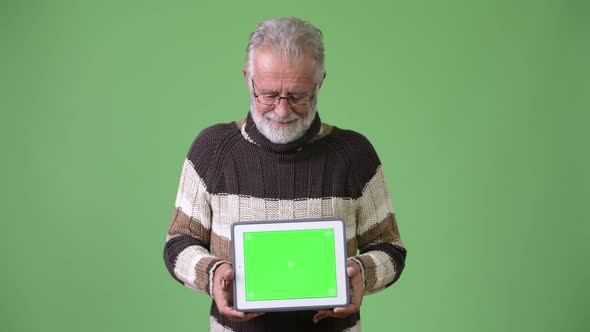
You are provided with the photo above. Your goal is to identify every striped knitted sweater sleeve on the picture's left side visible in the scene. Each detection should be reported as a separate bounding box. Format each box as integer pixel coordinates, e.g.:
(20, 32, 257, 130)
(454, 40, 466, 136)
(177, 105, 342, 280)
(164, 133, 232, 295)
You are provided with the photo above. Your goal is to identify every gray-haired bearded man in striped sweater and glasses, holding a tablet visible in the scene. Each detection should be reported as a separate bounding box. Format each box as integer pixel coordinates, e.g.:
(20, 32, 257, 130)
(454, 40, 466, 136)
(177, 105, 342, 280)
(164, 17, 406, 331)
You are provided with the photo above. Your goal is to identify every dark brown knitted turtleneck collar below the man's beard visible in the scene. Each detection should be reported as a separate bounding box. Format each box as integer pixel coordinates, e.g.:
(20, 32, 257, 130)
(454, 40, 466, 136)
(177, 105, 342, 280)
(244, 112, 322, 153)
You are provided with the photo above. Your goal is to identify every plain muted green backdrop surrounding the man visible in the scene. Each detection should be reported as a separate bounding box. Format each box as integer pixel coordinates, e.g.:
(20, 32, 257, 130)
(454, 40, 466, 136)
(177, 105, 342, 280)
(0, 0, 590, 331)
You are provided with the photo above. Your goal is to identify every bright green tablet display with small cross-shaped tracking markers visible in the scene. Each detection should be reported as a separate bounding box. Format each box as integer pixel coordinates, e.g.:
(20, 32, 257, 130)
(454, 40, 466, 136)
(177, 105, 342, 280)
(244, 229, 336, 301)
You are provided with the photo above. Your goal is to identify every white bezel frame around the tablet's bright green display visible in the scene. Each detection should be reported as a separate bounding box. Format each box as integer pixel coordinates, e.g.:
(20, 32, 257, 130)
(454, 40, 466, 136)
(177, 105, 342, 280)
(231, 218, 349, 312)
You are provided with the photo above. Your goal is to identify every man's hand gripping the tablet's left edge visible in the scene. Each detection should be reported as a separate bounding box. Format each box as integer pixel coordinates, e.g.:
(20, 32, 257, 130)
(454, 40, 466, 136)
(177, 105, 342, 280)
(213, 263, 264, 321)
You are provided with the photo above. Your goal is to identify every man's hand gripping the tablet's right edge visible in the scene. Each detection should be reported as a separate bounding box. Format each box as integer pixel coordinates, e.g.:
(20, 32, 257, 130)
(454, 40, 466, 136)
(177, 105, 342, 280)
(313, 261, 365, 323)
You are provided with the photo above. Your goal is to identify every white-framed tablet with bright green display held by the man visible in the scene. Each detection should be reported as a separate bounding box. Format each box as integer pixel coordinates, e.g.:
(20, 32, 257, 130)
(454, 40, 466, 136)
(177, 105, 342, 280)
(231, 219, 349, 312)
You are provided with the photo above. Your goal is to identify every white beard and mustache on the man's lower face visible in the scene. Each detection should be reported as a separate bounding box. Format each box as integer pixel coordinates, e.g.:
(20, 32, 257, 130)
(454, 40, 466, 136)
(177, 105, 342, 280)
(250, 98, 317, 144)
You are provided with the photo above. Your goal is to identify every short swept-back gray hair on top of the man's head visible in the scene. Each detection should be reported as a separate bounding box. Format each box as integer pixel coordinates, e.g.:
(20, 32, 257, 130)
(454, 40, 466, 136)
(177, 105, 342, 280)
(246, 16, 325, 81)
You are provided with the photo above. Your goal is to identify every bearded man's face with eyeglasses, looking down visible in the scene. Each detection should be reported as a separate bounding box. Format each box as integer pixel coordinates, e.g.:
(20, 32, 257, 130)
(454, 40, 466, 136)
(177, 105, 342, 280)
(246, 48, 316, 144)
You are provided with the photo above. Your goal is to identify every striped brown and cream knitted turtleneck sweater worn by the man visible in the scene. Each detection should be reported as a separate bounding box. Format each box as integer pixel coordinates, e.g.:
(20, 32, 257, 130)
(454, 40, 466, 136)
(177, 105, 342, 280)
(164, 114, 406, 332)
